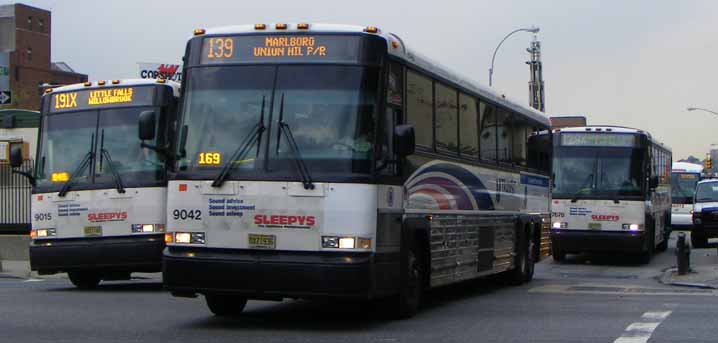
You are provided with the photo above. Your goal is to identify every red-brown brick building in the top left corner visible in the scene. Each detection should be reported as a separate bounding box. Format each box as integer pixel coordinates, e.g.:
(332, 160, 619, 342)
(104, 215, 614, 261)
(0, 4, 87, 110)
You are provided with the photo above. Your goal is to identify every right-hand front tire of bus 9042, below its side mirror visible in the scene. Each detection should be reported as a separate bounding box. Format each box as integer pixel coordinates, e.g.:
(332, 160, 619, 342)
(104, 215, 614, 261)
(397, 244, 426, 319)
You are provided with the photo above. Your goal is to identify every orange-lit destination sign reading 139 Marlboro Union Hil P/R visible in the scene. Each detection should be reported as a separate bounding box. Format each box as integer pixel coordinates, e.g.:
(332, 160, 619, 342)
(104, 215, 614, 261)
(200, 35, 360, 64)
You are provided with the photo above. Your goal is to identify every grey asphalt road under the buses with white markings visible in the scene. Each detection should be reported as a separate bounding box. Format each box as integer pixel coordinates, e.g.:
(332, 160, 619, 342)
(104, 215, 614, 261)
(0, 232, 718, 343)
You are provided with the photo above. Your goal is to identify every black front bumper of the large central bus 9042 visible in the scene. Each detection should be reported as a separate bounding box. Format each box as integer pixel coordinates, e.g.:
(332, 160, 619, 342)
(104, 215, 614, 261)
(162, 247, 374, 300)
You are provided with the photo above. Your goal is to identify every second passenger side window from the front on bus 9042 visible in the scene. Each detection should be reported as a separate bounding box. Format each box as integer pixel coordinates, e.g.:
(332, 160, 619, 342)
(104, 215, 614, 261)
(435, 83, 459, 154)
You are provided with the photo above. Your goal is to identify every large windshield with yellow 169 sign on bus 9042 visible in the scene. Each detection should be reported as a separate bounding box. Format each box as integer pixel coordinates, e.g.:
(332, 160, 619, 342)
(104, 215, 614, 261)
(178, 65, 378, 180)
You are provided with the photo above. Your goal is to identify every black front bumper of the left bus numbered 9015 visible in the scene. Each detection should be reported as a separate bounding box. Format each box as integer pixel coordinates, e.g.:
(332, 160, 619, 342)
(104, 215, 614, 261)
(30, 234, 165, 274)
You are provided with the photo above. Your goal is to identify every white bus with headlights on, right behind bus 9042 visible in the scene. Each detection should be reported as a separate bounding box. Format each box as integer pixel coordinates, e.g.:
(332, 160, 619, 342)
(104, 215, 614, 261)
(551, 126, 671, 262)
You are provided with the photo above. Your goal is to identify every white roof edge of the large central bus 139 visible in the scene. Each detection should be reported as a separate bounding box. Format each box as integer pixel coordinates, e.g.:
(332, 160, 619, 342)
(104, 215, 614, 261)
(200, 23, 551, 126)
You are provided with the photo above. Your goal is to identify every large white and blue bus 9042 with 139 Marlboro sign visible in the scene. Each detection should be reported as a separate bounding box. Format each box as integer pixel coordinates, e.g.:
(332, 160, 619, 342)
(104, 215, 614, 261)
(163, 24, 552, 316)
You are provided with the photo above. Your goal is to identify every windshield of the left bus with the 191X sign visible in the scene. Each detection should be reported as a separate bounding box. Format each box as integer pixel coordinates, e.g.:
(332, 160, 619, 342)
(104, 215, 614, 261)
(37, 107, 164, 189)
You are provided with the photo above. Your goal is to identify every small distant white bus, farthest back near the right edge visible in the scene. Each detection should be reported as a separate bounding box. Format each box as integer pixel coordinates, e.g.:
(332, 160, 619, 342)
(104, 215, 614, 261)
(671, 162, 703, 230)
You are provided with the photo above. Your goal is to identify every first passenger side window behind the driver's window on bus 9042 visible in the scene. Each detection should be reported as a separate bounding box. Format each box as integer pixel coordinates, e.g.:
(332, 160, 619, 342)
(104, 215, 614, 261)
(406, 70, 434, 148)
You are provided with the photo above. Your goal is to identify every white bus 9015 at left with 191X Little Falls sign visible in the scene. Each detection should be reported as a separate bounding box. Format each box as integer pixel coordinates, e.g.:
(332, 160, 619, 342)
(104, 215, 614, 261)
(11, 80, 179, 288)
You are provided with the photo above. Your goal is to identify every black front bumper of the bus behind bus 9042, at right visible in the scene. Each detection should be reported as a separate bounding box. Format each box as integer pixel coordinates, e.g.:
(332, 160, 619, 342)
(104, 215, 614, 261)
(551, 230, 647, 253)
